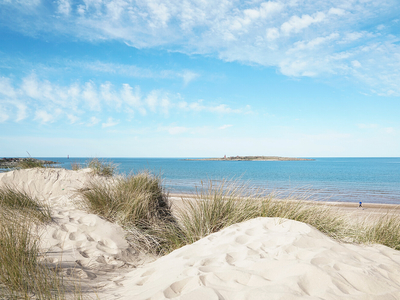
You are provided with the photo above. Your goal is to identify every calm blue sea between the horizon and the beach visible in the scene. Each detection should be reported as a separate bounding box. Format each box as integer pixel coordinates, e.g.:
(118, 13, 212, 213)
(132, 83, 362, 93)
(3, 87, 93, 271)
(6, 157, 400, 204)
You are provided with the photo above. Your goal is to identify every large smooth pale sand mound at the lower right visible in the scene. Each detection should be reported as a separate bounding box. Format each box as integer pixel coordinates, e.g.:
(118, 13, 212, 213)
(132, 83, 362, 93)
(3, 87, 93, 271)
(118, 218, 400, 300)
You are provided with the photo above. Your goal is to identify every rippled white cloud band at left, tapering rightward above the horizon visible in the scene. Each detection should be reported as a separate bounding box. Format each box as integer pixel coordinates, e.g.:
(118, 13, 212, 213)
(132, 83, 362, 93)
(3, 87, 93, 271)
(0, 73, 249, 128)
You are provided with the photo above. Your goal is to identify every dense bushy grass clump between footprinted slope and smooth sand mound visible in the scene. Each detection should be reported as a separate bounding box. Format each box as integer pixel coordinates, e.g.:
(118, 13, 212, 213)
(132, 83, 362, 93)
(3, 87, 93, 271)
(79, 171, 176, 254)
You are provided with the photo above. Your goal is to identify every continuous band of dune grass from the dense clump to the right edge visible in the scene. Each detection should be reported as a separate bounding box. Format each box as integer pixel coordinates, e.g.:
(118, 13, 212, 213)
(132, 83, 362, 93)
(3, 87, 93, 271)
(78, 171, 400, 255)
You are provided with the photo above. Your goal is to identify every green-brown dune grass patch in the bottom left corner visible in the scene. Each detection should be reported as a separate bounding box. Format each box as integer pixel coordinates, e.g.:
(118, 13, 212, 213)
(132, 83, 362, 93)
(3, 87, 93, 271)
(0, 187, 80, 300)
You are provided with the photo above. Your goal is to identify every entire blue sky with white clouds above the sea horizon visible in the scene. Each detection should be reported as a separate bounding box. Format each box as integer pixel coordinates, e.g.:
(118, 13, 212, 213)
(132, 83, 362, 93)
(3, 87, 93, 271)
(0, 0, 400, 157)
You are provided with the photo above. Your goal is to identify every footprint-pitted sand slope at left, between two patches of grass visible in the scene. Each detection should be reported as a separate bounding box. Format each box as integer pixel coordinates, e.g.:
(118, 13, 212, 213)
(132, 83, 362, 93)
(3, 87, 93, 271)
(0, 168, 154, 299)
